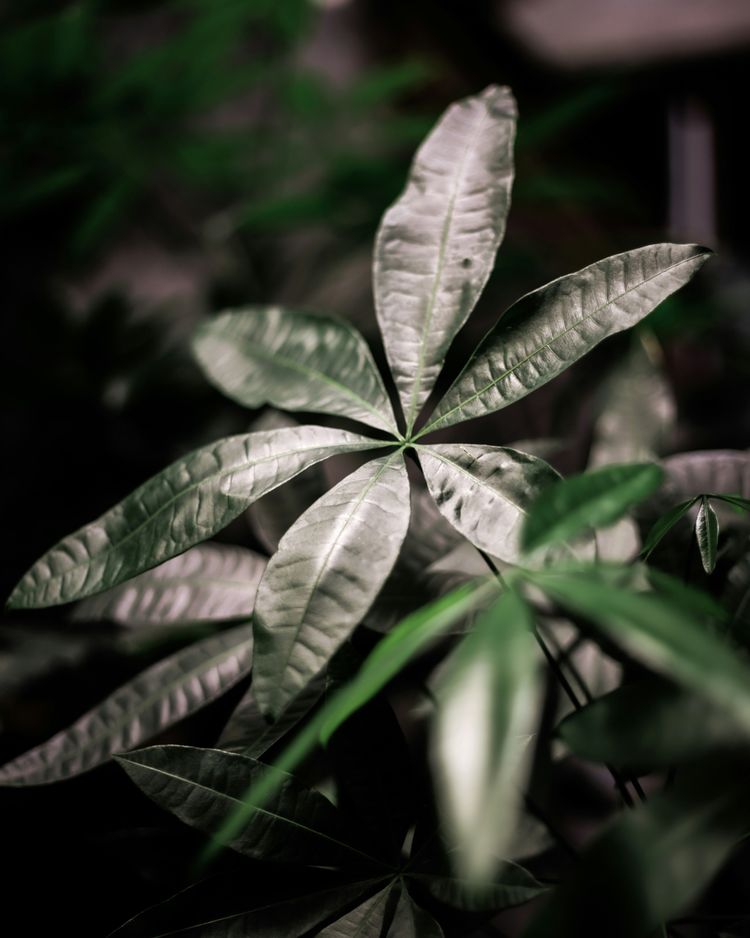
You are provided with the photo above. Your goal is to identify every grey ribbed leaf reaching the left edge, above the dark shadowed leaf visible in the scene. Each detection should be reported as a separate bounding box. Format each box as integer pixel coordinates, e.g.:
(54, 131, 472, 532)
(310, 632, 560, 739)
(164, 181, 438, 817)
(0, 625, 253, 785)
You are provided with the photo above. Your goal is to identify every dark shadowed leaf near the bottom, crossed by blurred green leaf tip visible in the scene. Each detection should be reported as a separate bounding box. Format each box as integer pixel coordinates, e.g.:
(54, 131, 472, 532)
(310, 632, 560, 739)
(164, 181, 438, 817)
(117, 746, 388, 866)
